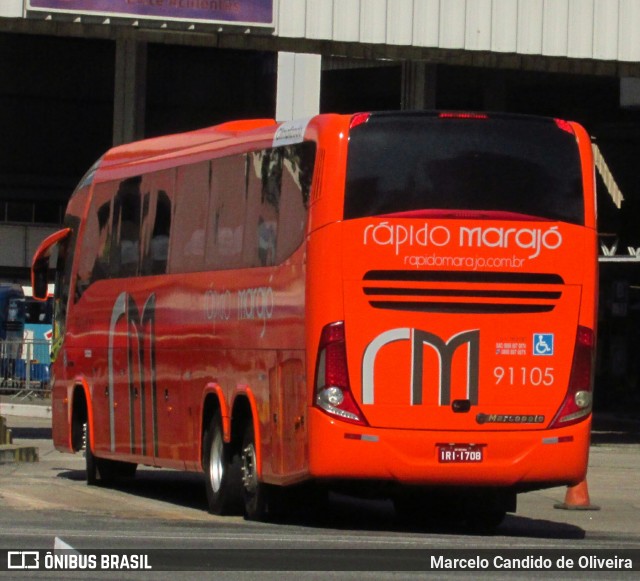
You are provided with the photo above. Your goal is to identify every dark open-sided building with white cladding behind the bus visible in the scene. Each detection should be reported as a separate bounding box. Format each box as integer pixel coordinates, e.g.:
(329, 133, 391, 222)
(0, 0, 640, 401)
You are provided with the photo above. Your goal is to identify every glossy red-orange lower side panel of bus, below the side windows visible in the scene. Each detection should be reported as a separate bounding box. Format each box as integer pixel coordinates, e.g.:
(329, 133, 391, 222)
(64, 253, 305, 474)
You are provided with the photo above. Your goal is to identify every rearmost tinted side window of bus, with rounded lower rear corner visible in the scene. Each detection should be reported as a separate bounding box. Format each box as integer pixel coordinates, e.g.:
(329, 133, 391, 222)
(205, 142, 316, 270)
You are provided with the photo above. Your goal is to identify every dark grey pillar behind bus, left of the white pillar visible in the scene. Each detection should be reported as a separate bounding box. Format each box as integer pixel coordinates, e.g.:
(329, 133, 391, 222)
(113, 38, 147, 145)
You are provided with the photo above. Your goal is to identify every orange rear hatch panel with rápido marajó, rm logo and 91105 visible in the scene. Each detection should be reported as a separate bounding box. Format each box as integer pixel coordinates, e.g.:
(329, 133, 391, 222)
(341, 220, 593, 431)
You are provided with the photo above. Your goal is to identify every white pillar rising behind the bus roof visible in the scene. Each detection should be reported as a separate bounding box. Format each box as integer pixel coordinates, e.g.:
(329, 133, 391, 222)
(276, 52, 322, 121)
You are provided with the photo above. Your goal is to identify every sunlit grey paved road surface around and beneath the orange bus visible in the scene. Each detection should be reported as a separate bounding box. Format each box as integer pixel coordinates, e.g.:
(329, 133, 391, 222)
(0, 416, 640, 579)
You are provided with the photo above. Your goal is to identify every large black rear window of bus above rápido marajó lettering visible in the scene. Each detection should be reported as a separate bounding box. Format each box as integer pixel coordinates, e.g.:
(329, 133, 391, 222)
(344, 114, 584, 224)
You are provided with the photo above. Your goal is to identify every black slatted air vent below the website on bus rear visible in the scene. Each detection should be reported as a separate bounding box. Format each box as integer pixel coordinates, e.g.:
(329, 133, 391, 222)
(363, 270, 564, 314)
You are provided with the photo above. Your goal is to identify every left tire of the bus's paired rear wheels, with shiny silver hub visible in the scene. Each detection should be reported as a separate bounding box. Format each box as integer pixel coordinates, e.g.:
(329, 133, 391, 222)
(202, 411, 242, 515)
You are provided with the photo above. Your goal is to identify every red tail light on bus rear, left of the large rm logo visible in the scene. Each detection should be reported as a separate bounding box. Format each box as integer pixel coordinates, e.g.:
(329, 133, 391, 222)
(315, 321, 367, 426)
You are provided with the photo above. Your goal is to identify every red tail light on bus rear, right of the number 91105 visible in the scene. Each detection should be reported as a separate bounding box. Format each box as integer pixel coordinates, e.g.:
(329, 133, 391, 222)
(549, 327, 595, 428)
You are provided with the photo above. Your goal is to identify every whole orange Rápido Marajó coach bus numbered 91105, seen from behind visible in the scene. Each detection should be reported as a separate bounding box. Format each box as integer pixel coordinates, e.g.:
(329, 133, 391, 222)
(33, 112, 597, 525)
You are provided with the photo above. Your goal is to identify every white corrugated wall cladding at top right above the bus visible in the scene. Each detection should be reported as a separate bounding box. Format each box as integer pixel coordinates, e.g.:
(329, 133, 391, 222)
(275, 0, 640, 62)
